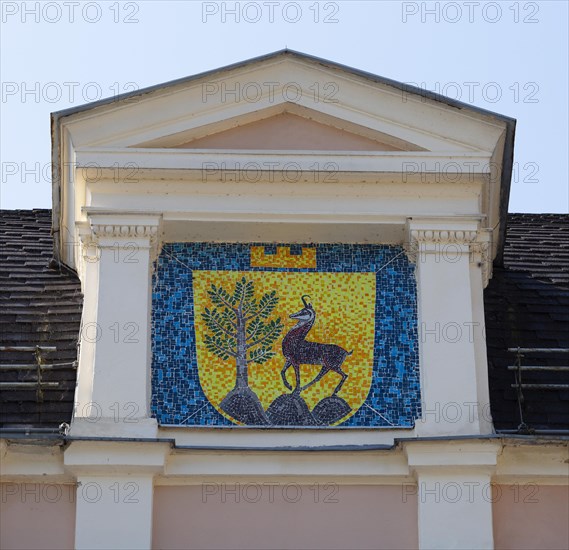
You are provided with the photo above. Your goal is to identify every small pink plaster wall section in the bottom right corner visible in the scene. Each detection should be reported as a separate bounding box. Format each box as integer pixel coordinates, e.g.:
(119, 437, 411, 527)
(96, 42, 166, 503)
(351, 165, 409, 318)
(492, 483, 569, 550)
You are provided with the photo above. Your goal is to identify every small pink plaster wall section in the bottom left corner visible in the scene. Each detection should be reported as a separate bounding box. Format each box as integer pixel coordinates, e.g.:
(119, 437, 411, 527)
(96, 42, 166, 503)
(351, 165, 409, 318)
(0, 483, 76, 550)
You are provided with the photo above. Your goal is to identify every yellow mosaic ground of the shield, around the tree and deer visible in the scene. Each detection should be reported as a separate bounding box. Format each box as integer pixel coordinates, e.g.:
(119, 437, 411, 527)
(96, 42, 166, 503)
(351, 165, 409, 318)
(193, 271, 375, 422)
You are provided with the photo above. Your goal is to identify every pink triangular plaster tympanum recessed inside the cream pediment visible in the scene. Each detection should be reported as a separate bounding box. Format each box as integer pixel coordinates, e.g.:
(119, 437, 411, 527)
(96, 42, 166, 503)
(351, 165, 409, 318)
(178, 113, 400, 151)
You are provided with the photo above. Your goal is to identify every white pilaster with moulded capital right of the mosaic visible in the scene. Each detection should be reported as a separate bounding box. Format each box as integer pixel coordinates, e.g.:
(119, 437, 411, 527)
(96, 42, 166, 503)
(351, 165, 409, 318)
(408, 219, 489, 436)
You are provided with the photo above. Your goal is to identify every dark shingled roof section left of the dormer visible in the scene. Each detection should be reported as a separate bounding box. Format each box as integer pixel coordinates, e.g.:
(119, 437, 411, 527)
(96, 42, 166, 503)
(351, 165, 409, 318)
(0, 210, 83, 428)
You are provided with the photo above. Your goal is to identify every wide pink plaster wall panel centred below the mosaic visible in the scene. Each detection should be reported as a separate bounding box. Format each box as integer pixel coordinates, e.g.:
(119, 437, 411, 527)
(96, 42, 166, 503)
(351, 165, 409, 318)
(153, 482, 418, 550)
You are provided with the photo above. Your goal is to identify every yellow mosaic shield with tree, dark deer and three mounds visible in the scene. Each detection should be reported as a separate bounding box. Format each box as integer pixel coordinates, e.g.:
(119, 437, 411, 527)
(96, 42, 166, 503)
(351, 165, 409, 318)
(194, 271, 375, 426)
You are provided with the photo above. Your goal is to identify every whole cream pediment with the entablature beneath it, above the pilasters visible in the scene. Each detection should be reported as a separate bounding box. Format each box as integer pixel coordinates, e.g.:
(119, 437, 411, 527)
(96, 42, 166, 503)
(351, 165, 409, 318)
(53, 51, 514, 276)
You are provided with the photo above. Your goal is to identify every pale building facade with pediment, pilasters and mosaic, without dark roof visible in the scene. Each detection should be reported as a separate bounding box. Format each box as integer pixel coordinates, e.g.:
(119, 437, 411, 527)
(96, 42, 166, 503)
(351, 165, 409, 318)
(1, 50, 569, 549)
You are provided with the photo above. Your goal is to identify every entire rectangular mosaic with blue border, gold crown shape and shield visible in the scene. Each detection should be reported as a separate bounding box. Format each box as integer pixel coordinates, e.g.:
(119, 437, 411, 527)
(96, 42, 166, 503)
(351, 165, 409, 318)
(151, 243, 421, 428)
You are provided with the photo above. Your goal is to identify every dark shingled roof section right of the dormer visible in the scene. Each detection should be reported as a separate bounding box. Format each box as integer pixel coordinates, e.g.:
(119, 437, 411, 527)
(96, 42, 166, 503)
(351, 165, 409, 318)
(484, 214, 569, 431)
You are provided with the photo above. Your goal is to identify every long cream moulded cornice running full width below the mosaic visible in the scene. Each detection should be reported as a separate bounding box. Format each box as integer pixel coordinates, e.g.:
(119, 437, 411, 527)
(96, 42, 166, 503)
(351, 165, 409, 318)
(0, 436, 569, 485)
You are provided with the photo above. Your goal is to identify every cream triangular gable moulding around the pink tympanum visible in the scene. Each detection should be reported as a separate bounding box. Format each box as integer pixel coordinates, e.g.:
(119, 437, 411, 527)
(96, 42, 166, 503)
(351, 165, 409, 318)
(58, 51, 503, 152)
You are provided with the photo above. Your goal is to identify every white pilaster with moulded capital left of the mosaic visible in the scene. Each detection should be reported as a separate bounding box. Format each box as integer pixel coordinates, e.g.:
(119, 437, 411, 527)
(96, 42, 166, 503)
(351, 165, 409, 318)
(71, 215, 160, 437)
